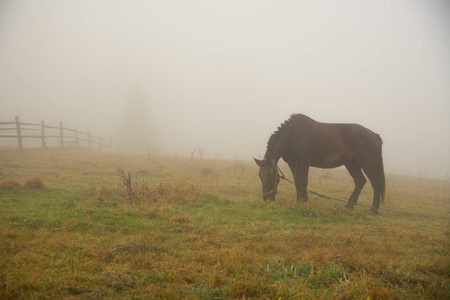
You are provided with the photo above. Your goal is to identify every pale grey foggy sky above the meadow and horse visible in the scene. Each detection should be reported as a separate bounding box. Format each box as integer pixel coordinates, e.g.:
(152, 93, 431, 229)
(0, 0, 450, 179)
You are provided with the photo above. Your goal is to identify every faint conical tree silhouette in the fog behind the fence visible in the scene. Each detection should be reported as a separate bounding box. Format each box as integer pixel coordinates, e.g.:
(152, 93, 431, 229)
(119, 86, 156, 153)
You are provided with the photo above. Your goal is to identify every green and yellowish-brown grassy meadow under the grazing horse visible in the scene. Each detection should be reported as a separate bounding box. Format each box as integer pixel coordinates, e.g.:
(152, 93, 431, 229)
(0, 149, 450, 299)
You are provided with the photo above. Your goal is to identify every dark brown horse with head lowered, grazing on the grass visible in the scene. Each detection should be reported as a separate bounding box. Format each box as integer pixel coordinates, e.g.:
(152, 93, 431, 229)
(255, 114, 386, 214)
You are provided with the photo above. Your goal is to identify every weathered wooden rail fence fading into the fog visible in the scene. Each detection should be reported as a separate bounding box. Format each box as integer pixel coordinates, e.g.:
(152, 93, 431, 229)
(0, 116, 117, 151)
